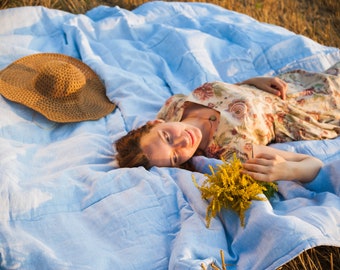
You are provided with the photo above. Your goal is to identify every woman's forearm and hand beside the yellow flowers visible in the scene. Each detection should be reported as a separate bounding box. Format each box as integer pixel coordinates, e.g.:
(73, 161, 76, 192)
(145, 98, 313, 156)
(243, 145, 323, 182)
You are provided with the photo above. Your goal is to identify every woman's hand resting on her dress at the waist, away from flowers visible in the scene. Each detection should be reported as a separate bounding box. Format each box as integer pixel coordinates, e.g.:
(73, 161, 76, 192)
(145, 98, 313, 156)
(237, 77, 287, 99)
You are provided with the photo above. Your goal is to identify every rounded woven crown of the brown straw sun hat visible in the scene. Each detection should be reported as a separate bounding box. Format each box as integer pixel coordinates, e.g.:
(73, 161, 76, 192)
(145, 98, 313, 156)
(35, 60, 86, 98)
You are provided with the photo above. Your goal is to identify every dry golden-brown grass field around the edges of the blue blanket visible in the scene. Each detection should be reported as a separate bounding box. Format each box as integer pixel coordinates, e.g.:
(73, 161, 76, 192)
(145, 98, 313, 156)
(0, 0, 340, 270)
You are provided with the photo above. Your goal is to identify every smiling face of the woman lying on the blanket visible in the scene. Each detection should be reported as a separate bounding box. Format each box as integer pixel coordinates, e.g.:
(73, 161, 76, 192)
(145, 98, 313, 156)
(140, 120, 202, 167)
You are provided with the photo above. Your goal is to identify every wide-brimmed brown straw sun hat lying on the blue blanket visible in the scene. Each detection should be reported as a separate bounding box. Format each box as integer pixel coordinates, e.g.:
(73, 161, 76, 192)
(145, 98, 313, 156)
(0, 53, 116, 123)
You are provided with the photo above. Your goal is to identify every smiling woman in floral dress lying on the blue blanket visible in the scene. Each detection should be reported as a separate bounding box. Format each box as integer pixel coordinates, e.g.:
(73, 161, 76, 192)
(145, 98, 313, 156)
(116, 63, 340, 182)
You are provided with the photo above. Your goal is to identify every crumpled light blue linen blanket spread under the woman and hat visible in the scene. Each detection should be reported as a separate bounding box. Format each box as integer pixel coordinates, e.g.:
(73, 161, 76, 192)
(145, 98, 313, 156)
(0, 2, 340, 270)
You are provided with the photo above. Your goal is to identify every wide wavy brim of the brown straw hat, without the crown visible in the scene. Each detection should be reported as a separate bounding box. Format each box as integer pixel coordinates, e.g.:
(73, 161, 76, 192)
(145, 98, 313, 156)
(0, 53, 116, 123)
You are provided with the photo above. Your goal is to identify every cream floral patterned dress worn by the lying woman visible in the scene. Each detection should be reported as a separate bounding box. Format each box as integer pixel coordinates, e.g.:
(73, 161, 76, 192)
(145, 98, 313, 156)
(158, 63, 340, 160)
